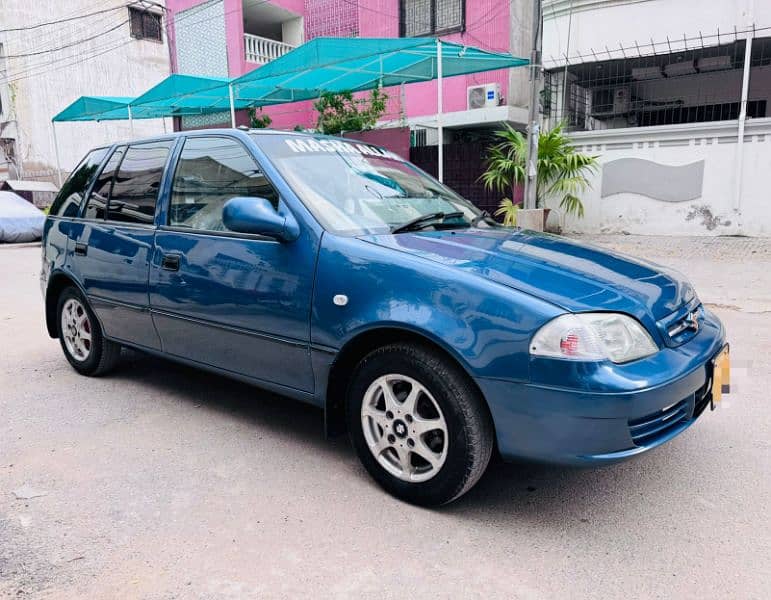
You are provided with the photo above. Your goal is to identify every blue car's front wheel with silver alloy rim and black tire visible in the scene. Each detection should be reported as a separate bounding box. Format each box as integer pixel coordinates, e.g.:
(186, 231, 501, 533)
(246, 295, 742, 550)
(346, 343, 494, 506)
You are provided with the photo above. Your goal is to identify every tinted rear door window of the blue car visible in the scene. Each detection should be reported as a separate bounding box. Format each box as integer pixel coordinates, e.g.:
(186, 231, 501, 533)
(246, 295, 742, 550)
(107, 140, 174, 223)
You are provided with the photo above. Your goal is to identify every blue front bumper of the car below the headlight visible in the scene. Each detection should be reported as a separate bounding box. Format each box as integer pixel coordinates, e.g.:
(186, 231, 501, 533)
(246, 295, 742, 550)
(477, 310, 725, 466)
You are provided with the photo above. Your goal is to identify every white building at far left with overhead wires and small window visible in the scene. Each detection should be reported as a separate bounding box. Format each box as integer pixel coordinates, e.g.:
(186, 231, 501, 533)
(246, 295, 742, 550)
(0, 0, 170, 182)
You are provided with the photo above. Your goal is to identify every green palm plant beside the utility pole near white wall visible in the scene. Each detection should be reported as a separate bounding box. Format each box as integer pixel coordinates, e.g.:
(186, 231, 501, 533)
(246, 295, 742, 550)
(480, 123, 597, 225)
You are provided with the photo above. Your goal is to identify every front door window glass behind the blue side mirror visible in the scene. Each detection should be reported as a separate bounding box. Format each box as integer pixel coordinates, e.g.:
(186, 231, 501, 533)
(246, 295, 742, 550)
(169, 137, 278, 231)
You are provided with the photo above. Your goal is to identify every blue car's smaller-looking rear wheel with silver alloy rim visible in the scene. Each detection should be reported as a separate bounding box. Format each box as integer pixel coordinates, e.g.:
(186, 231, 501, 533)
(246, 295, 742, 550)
(56, 286, 121, 376)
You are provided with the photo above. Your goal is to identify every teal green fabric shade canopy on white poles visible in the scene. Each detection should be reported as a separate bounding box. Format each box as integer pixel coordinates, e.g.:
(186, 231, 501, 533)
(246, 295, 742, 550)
(53, 38, 528, 121)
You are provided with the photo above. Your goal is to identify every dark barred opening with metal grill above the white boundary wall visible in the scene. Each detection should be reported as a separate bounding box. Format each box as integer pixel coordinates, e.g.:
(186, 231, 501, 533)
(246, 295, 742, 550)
(541, 36, 771, 131)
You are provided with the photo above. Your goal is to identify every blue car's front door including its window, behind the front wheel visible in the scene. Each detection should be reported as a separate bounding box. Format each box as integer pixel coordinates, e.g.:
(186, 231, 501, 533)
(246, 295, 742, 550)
(150, 135, 318, 392)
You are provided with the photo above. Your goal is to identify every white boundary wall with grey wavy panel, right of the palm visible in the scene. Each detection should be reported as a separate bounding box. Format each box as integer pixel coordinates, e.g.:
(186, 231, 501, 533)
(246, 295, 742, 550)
(549, 119, 771, 236)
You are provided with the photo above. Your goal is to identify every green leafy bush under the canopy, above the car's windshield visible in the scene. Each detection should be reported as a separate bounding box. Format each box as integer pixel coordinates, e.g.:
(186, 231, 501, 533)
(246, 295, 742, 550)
(313, 89, 388, 135)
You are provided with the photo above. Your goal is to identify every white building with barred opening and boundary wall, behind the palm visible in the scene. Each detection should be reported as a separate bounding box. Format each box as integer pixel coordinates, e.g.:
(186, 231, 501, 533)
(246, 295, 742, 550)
(543, 0, 771, 236)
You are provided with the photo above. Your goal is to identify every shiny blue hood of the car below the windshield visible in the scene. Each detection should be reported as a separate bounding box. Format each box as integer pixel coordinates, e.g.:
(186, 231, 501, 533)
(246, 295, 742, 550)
(361, 228, 695, 320)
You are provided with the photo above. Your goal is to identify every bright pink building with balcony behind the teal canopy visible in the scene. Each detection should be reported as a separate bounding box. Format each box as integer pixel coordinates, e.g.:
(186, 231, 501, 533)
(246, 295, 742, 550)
(166, 0, 530, 135)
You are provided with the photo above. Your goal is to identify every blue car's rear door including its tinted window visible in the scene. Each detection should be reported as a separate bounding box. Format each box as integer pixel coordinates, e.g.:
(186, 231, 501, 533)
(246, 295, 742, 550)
(70, 140, 175, 349)
